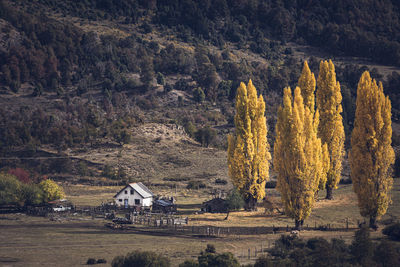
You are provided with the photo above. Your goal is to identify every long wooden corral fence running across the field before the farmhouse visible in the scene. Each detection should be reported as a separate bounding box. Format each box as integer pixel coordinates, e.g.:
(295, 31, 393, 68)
(0, 205, 363, 237)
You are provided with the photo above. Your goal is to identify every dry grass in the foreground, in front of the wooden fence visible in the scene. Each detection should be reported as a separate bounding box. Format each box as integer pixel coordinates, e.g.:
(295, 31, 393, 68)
(0, 215, 353, 266)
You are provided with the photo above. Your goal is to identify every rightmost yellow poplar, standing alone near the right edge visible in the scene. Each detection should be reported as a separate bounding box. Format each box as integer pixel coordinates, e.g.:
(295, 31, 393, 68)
(350, 71, 395, 228)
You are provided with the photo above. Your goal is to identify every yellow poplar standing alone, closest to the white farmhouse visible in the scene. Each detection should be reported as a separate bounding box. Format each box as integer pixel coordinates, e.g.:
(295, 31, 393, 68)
(228, 80, 271, 210)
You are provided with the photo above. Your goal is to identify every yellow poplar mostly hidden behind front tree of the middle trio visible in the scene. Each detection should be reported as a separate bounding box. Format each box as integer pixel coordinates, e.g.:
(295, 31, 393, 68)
(297, 61, 330, 193)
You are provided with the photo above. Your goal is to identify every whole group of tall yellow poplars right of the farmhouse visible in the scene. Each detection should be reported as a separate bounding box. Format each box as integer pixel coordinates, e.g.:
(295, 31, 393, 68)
(228, 61, 394, 228)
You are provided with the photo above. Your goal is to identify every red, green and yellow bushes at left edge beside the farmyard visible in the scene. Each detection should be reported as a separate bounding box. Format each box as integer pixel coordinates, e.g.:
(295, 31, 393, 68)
(0, 168, 65, 206)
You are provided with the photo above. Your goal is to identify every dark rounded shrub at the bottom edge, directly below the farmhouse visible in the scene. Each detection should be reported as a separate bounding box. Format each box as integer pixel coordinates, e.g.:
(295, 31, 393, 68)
(111, 250, 170, 267)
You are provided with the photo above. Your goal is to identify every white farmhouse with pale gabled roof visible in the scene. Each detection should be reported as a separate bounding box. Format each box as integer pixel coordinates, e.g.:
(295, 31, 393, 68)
(114, 182, 154, 208)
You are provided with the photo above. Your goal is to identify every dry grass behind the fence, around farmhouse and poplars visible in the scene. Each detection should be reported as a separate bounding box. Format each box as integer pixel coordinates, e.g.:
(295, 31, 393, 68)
(64, 179, 400, 227)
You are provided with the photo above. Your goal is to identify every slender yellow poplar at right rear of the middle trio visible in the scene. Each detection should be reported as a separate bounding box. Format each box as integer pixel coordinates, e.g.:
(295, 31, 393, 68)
(317, 60, 345, 199)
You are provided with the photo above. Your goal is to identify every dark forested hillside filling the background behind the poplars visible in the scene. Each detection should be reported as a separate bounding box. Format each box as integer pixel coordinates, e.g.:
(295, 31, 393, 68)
(0, 0, 400, 180)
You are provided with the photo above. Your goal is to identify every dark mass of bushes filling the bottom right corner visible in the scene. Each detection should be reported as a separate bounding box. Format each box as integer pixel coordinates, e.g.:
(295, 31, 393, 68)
(266, 227, 400, 266)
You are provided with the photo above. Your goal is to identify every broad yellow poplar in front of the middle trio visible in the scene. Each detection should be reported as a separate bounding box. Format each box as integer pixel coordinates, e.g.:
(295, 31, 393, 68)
(274, 87, 323, 229)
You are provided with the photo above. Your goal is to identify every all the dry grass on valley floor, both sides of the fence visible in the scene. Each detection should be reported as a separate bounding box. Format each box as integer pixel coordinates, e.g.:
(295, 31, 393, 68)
(0, 179, 400, 266)
